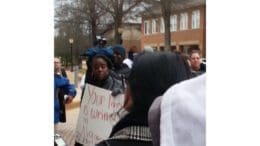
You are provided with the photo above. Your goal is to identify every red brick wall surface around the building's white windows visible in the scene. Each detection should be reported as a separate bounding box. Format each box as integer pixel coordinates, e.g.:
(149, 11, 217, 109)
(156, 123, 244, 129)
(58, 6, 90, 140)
(141, 5, 206, 57)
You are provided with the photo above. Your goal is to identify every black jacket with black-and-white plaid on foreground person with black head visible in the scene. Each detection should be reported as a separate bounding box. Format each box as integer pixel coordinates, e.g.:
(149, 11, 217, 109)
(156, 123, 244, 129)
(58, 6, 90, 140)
(96, 111, 153, 146)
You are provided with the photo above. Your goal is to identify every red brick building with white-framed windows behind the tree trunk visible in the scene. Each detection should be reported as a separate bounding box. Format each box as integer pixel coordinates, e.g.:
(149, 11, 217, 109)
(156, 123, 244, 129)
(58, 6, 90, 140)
(141, 0, 206, 57)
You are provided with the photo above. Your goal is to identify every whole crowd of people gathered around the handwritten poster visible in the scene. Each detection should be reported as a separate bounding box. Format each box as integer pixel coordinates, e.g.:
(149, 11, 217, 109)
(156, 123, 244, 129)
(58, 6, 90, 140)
(54, 37, 206, 146)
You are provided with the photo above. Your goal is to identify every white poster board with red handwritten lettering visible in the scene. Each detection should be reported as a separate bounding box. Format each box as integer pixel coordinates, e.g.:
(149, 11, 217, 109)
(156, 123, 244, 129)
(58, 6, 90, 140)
(76, 84, 124, 146)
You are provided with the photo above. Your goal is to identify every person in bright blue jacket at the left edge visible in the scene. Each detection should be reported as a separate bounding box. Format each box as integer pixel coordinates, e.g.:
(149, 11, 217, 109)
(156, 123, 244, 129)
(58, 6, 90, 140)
(54, 58, 76, 131)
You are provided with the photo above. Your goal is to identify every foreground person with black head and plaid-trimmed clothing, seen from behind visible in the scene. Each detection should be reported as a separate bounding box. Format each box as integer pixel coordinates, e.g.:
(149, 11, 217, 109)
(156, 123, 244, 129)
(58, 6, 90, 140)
(97, 53, 190, 146)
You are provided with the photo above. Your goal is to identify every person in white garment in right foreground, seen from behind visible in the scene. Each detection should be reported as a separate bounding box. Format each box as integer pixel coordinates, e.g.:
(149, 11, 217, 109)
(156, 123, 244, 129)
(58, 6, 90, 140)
(159, 74, 206, 146)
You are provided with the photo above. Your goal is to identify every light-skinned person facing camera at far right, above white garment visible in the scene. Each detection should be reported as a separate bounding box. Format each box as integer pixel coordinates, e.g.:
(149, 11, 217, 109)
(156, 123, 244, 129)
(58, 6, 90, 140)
(190, 50, 205, 77)
